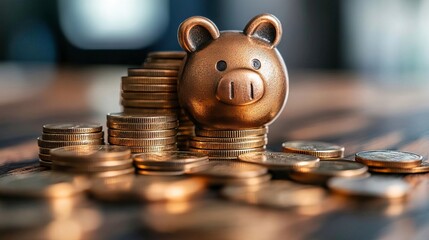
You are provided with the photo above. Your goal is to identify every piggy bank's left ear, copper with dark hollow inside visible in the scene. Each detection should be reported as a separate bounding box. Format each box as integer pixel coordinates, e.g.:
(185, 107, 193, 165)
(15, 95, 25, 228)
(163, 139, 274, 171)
(177, 16, 219, 52)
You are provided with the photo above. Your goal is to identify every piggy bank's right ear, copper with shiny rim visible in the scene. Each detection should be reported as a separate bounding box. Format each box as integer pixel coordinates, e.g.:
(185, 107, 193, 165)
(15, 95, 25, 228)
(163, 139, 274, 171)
(243, 14, 282, 48)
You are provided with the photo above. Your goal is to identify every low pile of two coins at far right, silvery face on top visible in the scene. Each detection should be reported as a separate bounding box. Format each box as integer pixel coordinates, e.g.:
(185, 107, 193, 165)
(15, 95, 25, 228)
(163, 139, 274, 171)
(355, 150, 429, 174)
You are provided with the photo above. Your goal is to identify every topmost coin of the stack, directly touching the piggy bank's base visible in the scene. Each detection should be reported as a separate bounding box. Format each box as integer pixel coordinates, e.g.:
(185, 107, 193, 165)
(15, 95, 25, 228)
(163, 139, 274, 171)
(195, 127, 268, 138)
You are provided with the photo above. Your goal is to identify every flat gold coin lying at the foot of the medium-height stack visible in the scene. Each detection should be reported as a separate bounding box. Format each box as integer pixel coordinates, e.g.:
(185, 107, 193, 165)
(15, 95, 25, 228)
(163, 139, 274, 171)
(133, 151, 208, 166)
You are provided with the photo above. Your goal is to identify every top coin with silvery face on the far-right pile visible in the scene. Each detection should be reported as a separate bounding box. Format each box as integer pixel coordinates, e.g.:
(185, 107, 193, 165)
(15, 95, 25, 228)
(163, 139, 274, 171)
(355, 150, 423, 168)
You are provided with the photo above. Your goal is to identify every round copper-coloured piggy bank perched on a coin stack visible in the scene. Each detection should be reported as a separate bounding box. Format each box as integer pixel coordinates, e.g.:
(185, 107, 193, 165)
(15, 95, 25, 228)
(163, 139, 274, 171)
(177, 14, 288, 130)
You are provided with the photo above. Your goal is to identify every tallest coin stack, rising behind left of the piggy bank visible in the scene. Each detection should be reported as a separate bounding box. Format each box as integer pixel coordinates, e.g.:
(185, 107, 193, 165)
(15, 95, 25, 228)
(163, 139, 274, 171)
(121, 51, 194, 150)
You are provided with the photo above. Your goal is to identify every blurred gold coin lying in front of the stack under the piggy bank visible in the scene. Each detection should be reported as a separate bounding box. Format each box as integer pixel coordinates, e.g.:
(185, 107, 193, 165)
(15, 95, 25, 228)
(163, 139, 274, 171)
(190, 161, 268, 178)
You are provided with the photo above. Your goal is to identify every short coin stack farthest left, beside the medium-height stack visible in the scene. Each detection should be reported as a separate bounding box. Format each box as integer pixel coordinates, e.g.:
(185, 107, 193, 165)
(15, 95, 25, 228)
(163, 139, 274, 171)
(37, 123, 104, 168)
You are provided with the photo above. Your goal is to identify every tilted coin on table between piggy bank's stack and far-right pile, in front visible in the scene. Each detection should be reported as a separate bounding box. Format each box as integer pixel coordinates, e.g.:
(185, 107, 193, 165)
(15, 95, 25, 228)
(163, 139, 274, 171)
(289, 160, 368, 184)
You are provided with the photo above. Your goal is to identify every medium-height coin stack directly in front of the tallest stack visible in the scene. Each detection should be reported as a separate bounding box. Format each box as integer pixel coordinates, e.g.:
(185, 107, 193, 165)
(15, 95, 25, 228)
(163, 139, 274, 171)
(107, 113, 178, 153)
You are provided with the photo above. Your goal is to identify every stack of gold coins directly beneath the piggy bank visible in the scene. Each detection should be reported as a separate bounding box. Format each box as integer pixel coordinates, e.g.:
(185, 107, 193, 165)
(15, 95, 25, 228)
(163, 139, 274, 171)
(189, 127, 268, 160)
